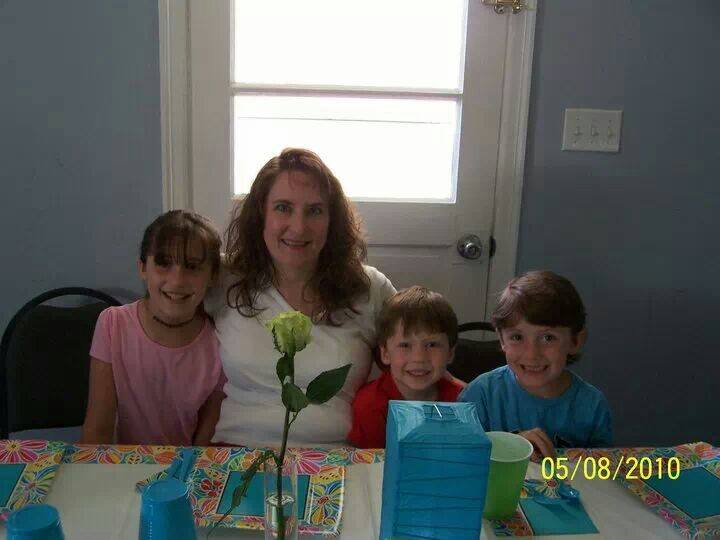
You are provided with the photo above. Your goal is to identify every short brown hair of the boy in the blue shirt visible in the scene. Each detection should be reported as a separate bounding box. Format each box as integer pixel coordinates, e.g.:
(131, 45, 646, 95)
(491, 270, 587, 363)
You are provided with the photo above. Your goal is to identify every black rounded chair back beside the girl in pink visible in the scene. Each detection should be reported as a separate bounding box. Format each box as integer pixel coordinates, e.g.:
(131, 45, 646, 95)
(0, 287, 120, 439)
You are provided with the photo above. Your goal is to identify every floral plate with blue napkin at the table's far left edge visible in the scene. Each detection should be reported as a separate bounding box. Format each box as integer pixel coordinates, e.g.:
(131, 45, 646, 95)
(0, 440, 65, 521)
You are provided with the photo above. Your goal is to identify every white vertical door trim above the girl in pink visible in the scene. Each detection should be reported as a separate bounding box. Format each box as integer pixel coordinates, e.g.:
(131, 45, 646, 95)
(158, 0, 192, 211)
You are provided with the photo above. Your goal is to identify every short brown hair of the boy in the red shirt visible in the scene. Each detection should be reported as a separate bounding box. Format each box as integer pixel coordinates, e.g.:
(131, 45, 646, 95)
(375, 285, 457, 348)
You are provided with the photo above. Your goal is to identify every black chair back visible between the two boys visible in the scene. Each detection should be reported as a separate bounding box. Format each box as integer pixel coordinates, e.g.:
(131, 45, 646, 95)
(448, 322, 505, 383)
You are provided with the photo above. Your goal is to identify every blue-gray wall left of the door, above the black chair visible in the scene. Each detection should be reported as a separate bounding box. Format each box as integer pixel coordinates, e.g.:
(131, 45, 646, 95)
(0, 0, 162, 329)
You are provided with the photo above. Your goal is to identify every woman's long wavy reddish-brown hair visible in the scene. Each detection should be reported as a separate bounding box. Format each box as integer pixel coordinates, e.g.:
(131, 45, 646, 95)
(226, 148, 370, 324)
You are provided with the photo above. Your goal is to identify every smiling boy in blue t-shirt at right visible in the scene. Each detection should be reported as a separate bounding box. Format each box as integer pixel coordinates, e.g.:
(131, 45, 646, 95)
(458, 271, 612, 460)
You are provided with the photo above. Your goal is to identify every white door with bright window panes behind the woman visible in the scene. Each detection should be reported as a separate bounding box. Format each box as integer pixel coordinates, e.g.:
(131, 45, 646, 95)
(171, 0, 534, 322)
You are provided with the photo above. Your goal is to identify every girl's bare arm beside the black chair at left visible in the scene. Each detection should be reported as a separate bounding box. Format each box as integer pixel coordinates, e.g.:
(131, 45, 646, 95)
(80, 357, 117, 444)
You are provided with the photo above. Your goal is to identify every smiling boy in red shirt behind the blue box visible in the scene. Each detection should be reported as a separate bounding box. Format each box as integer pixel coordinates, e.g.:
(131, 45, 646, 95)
(348, 286, 463, 448)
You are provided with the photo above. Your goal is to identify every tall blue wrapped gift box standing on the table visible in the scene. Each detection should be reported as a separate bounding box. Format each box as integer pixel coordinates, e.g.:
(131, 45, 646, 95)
(380, 401, 491, 540)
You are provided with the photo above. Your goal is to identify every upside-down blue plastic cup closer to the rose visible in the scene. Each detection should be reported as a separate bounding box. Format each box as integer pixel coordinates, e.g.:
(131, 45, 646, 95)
(139, 478, 197, 540)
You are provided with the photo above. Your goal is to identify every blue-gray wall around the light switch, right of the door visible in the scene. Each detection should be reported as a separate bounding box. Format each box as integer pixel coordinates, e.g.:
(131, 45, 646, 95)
(518, 0, 720, 445)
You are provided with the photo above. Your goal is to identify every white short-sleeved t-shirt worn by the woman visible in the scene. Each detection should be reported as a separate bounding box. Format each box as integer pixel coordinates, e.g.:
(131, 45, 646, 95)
(209, 266, 395, 447)
